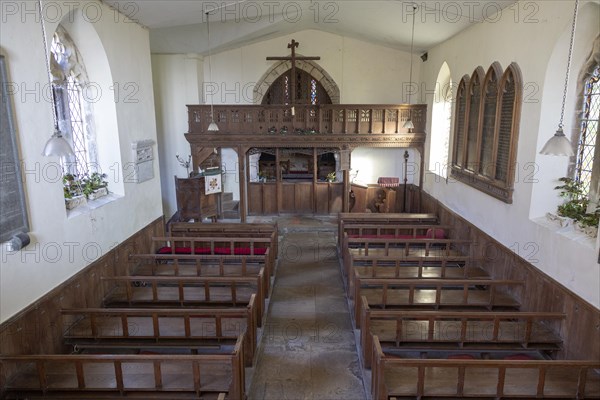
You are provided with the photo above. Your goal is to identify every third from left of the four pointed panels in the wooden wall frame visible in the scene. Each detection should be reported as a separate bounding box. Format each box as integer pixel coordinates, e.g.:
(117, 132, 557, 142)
(479, 63, 502, 178)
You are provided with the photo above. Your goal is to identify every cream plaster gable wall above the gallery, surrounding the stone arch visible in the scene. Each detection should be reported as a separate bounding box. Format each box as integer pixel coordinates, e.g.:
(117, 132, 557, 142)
(205, 30, 421, 104)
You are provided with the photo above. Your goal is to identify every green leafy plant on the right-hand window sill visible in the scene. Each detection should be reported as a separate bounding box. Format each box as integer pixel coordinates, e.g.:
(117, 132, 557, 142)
(554, 178, 600, 227)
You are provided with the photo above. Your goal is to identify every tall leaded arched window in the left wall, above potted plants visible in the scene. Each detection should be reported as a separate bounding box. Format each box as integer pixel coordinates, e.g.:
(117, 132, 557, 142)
(50, 25, 98, 177)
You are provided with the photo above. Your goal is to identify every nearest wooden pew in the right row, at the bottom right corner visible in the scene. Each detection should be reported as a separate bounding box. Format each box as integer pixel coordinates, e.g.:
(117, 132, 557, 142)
(371, 336, 600, 400)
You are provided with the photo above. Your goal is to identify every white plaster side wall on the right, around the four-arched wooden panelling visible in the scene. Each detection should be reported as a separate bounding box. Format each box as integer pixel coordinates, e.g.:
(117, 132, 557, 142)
(421, 0, 600, 307)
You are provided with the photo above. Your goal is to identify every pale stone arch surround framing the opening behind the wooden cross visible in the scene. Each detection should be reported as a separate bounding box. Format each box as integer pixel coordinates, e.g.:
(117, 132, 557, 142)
(253, 54, 340, 104)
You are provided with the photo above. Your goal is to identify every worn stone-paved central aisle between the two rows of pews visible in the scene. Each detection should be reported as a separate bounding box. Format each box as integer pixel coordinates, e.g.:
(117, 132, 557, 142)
(248, 220, 367, 400)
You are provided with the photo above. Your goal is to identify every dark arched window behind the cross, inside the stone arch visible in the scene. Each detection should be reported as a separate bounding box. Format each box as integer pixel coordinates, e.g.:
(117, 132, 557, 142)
(262, 69, 331, 105)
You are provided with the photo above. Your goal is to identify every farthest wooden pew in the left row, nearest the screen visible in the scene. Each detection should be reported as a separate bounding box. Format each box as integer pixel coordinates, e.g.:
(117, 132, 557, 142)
(167, 222, 279, 265)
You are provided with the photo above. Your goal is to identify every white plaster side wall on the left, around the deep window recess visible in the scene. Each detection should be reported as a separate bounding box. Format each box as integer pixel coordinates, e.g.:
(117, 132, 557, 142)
(0, 1, 162, 321)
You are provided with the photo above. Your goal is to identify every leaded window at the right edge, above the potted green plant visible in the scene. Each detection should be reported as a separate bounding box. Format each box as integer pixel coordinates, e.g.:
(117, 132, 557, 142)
(575, 65, 600, 196)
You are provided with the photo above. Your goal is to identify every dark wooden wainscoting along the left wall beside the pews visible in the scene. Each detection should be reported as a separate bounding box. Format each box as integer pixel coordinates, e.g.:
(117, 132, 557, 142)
(0, 217, 164, 355)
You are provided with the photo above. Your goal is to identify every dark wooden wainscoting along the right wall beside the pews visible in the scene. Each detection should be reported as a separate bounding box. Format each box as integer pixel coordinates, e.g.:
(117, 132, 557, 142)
(421, 192, 600, 360)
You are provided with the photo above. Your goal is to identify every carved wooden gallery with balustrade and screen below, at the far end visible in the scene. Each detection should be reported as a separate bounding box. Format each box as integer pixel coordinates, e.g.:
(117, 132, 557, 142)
(185, 104, 427, 222)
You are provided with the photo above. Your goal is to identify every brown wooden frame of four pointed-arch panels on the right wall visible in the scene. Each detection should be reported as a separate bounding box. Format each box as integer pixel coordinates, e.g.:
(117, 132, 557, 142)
(451, 63, 523, 204)
